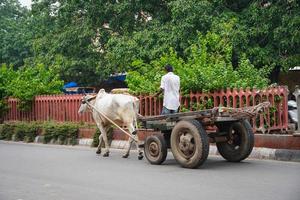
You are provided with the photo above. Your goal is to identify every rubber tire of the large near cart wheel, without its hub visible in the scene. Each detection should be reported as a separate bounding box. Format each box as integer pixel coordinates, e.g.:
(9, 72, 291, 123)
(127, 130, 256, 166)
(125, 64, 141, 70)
(170, 120, 209, 169)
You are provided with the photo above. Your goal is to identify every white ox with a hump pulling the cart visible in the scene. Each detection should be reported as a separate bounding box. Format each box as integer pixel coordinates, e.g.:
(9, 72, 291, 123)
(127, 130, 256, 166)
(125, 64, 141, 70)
(78, 89, 143, 159)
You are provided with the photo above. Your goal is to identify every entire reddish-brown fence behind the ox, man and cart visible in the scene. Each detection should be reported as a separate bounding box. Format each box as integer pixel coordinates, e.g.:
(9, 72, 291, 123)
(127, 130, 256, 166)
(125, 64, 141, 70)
(4, 86, 288, 132)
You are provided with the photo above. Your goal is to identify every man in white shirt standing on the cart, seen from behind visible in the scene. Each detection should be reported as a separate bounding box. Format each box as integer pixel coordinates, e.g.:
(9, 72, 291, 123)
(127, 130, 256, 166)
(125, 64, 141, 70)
(155, 64, 180, 115)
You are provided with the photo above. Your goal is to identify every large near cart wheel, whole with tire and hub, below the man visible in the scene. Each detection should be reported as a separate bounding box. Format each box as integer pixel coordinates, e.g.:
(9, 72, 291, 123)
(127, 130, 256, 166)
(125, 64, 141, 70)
(171, 120, 209, 168)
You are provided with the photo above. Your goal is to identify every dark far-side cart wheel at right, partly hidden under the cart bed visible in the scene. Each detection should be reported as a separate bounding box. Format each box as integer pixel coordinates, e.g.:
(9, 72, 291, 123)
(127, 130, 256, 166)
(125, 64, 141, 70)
(217, 120, 254, 162)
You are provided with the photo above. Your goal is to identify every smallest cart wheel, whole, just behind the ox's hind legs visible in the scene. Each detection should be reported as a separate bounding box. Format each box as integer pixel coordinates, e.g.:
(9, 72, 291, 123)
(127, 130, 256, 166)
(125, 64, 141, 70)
(144, 135, 168, 165)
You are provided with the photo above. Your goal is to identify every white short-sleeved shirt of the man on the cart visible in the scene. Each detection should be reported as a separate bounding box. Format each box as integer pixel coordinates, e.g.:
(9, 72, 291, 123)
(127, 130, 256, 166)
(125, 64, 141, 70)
(160, 72, 180, 110)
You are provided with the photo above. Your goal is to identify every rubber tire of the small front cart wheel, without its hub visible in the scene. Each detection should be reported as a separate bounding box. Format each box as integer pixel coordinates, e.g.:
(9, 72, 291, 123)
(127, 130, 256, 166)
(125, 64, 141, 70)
(144, 135, 168, 165)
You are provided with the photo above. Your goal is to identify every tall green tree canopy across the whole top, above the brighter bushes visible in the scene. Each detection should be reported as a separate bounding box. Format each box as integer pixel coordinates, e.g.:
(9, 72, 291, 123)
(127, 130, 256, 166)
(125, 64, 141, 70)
(0, 0, 300, 85)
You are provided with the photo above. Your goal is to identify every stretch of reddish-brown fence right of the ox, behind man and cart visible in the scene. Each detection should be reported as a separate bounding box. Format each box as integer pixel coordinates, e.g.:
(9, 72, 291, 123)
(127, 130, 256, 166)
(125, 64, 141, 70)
(139, 86, 288, 133)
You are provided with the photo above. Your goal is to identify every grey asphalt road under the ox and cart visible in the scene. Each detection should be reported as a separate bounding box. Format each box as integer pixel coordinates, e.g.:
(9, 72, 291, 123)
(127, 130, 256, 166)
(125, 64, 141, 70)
(0, 141, 300, 200)
